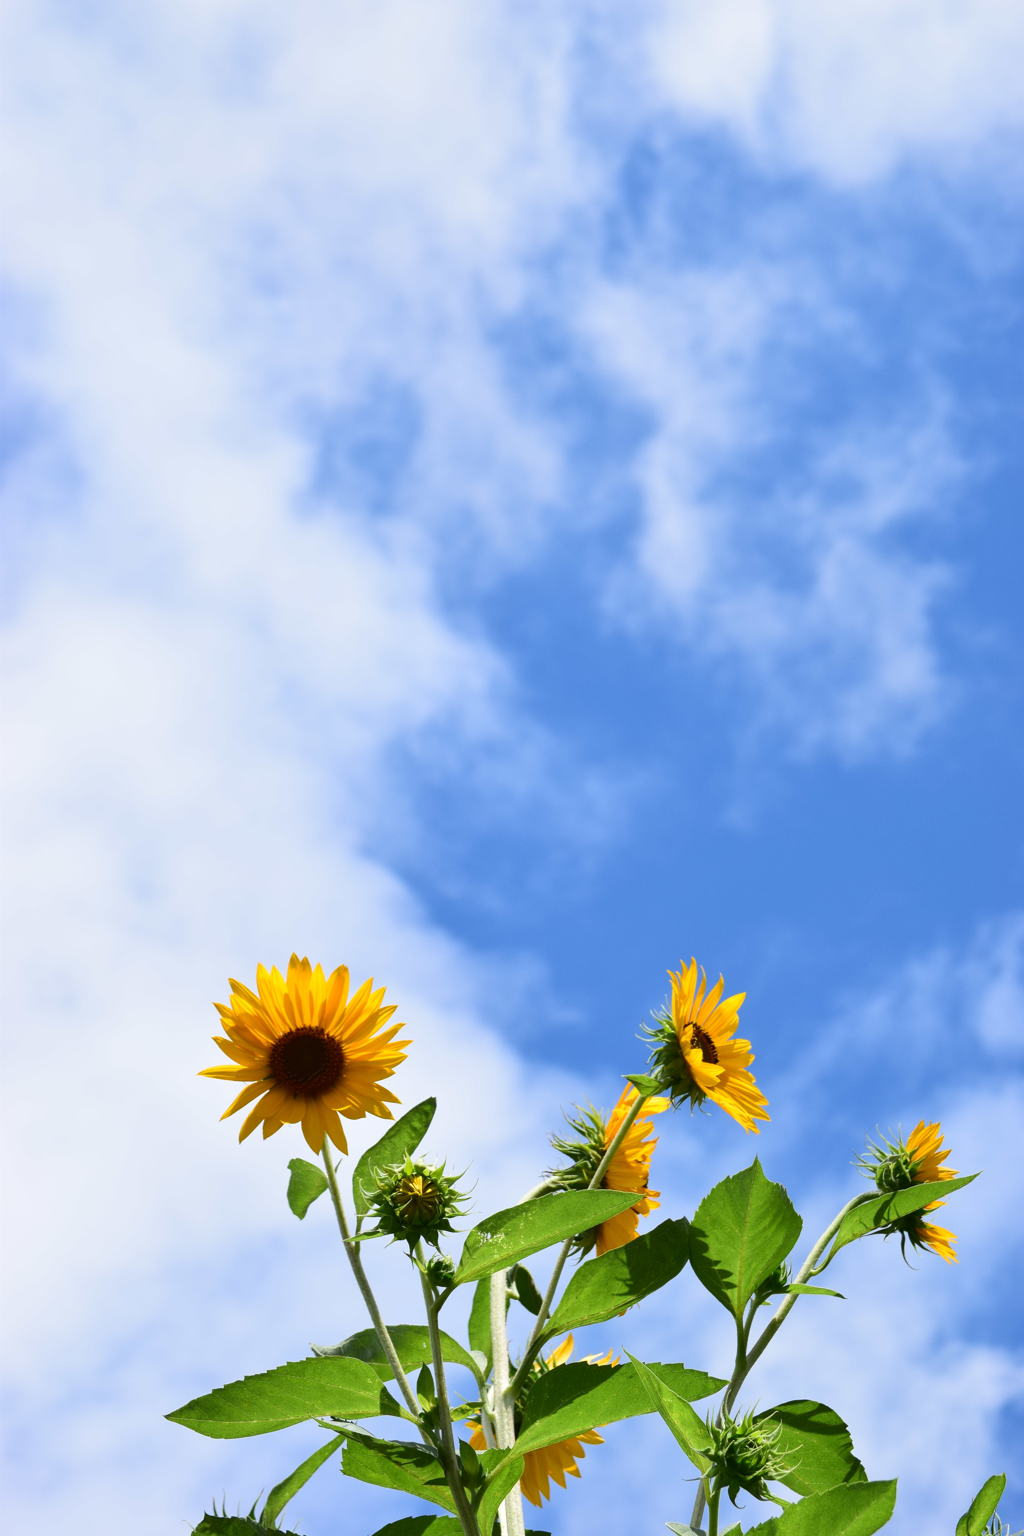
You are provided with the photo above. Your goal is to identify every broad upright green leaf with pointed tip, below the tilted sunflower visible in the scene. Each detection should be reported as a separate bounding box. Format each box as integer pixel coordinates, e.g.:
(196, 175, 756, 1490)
(689, 1158, 803, 1318)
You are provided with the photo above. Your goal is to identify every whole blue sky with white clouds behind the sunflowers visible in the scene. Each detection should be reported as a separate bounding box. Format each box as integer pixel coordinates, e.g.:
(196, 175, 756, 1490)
(0, 0, 1024, 1536)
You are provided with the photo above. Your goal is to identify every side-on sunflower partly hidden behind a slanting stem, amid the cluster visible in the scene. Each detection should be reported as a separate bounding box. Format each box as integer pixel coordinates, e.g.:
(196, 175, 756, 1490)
(551, 1083, 668, 1255)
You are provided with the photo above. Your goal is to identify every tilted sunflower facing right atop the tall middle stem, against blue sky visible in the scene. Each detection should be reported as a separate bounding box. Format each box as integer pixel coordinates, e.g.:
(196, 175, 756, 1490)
(646, 960, 769, 1130)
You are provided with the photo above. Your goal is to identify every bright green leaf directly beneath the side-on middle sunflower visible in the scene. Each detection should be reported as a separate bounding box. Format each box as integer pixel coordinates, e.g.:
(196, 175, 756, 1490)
(454, 1189, 637, 1286)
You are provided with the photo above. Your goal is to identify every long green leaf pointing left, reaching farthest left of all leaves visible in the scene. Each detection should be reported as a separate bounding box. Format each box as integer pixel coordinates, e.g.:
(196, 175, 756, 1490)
(167, 1359, 398, 1439)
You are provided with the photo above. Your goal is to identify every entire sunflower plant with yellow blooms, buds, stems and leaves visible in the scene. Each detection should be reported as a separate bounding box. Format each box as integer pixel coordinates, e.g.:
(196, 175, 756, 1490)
(167, 955, 1006, 1536)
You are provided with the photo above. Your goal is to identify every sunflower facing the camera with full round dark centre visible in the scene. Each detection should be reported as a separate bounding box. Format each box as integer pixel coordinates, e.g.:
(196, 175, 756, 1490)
(200, 955, 408, 1152)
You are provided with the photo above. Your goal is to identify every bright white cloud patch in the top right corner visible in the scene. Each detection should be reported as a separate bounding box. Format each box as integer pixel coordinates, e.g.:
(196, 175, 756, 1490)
(649, 0, 1024, 184)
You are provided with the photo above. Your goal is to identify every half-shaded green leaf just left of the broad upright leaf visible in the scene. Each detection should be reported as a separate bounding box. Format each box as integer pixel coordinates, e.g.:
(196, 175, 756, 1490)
(545, 1221, 689, 1338)
